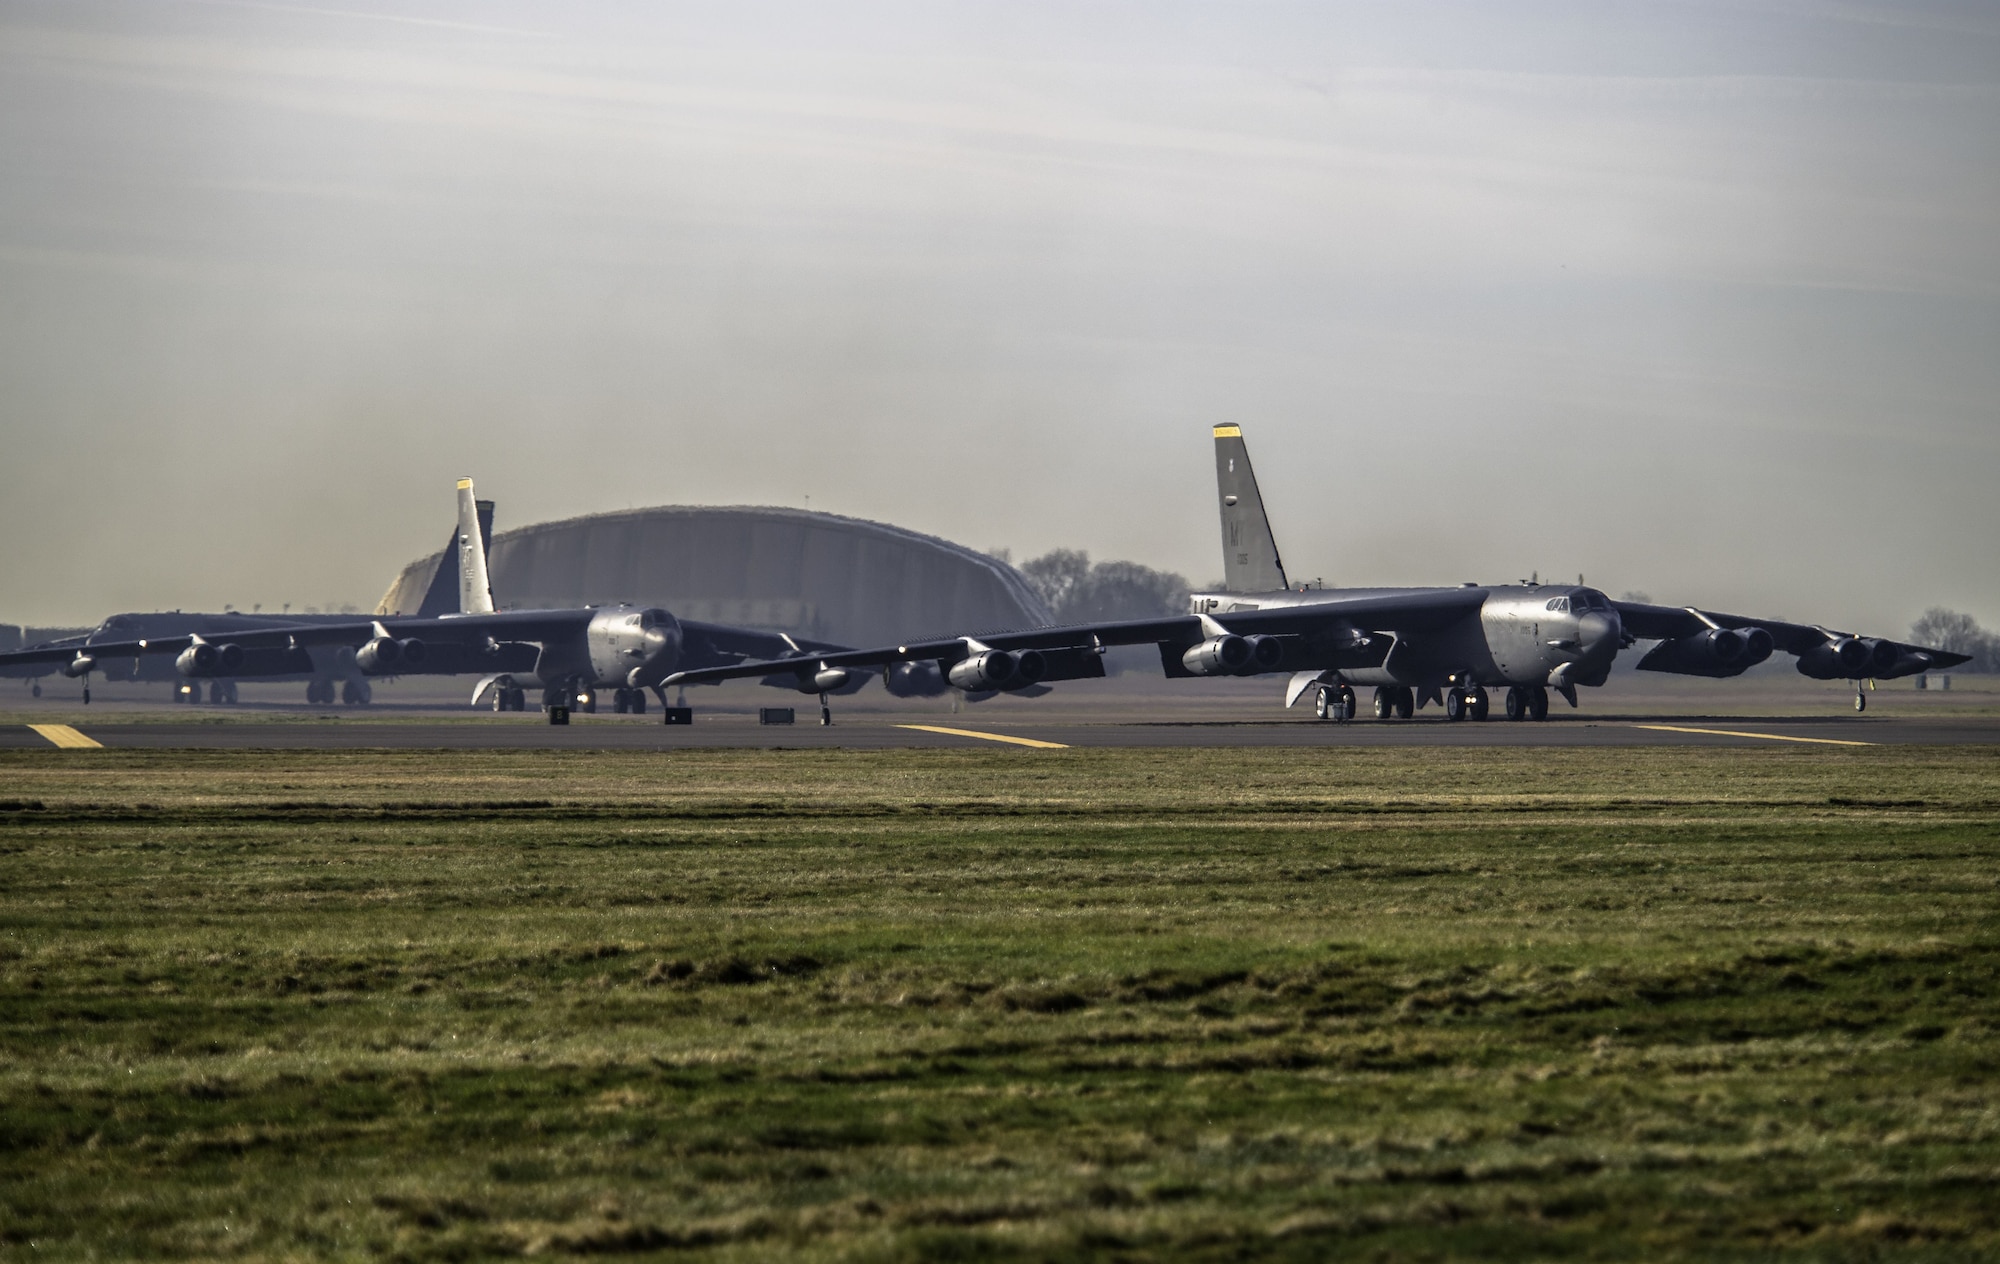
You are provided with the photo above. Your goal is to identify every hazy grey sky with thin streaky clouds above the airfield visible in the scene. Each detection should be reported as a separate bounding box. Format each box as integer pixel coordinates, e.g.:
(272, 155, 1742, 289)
(0, 0, 2000, 632)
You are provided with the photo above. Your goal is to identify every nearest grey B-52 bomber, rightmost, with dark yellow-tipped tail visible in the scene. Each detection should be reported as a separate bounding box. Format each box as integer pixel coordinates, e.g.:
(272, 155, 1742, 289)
(666, 426, 1966, 722)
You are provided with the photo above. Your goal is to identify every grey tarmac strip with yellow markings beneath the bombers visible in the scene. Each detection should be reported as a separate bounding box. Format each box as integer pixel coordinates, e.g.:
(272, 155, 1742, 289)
(0, 714, 2000, 750)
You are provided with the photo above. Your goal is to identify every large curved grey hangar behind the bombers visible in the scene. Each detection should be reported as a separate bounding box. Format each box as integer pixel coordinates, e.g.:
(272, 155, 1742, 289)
(376, 506, 1054, 646)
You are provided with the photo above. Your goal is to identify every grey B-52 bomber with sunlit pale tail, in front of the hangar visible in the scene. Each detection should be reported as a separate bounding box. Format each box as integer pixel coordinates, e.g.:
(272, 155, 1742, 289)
(0, 478, 864, 724)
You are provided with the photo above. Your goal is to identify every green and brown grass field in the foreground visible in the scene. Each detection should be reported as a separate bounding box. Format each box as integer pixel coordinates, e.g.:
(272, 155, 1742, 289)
(0, 748, 2000, 1260)
